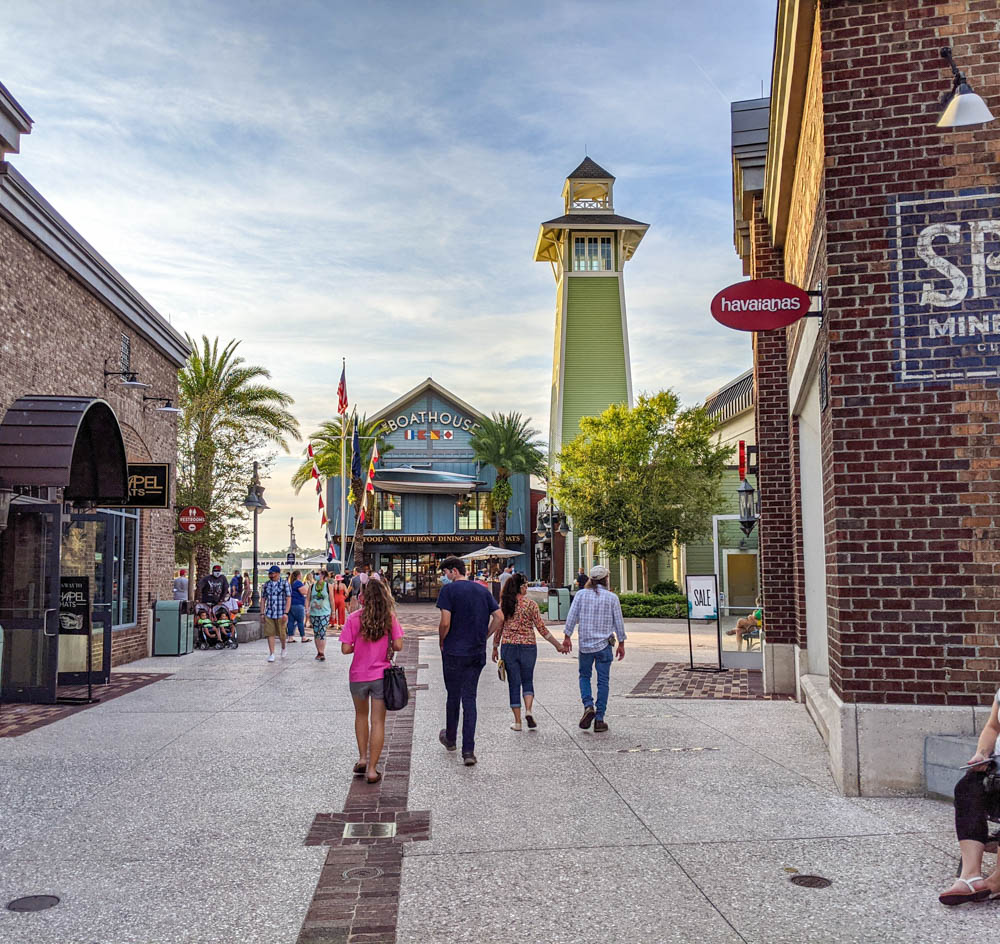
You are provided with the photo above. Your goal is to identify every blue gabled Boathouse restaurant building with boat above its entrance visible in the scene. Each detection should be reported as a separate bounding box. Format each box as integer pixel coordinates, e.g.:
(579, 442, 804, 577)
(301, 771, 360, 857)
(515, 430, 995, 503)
(328, 377, 534, 601)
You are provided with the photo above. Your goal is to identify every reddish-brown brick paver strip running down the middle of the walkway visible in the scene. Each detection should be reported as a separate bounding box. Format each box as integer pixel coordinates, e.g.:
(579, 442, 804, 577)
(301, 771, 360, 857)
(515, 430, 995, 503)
(298, 624, 437, 944)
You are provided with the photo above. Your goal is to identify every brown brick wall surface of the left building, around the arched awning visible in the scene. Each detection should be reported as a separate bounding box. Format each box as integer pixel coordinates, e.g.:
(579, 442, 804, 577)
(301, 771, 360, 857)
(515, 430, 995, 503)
(0, 220, 177, 665)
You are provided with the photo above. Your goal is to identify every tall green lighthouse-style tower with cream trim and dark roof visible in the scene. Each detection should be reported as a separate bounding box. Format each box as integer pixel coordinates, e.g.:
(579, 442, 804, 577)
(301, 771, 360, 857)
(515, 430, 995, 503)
(535, 157, 649, 580)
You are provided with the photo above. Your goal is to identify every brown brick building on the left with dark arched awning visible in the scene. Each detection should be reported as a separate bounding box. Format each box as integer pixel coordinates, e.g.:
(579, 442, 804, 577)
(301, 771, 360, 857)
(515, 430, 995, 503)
(0, 79, 188, 701)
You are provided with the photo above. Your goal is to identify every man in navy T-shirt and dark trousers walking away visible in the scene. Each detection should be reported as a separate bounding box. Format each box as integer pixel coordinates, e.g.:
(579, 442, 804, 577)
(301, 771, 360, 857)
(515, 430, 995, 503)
(437, 557, 503, 767)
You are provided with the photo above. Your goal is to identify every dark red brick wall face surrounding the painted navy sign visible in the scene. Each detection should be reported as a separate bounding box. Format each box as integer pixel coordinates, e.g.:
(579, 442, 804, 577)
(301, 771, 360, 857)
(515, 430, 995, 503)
(816, 0, 1000, 704)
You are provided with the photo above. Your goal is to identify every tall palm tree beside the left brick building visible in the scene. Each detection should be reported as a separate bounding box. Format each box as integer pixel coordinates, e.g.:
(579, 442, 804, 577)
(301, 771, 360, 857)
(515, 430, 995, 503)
(178, 335, 299, 579)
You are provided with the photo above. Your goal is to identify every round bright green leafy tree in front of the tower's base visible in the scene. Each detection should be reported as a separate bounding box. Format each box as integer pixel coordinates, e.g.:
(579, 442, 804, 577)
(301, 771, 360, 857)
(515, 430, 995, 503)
(555, 390, 732, 592)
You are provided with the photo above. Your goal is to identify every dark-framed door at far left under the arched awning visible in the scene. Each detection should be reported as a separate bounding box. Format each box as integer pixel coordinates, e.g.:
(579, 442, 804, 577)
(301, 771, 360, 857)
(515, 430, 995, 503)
(0, 503, 62, 704)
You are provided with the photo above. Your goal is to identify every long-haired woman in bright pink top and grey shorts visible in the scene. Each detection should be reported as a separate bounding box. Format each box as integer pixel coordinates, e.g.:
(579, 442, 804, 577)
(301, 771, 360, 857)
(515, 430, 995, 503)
(340, 580, 403, 783)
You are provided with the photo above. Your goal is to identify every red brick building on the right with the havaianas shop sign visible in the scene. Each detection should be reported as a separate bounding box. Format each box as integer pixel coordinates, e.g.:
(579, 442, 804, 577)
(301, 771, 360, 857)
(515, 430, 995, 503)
(733, 0, 1000, 794)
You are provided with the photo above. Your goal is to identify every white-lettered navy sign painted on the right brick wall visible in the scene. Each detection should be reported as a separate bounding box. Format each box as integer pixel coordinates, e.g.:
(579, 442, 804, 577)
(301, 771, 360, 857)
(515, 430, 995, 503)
(893, 190, 1000, 384)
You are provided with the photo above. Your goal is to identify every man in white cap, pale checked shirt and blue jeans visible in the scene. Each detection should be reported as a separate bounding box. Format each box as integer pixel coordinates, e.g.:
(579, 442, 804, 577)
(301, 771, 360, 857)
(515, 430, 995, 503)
(563, 564, 625, 733)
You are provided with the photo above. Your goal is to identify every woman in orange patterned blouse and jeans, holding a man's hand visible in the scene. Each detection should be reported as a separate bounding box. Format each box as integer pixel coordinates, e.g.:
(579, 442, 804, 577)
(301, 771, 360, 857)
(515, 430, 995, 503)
(493, 574, 565, 731)
